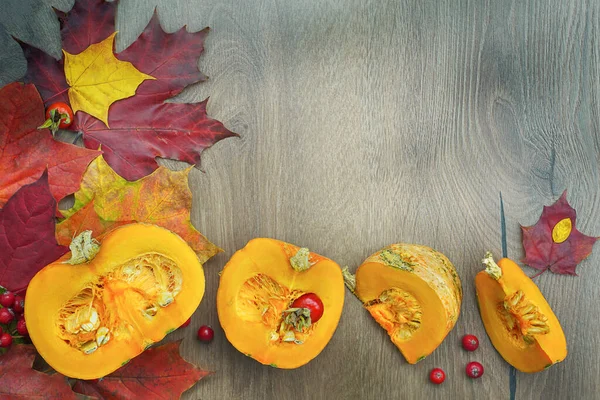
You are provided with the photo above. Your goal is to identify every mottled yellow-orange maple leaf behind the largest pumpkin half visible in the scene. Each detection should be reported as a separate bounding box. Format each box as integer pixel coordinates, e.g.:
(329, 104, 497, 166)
(59, 157, 221, 263)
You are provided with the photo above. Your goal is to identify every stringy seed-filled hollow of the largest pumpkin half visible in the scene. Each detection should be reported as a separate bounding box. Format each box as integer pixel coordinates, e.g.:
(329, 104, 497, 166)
(55, 253, 183, 354)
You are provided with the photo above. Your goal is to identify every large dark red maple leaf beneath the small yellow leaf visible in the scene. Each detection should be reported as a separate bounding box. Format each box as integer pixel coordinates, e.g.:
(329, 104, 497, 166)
(21, 0, 236, 180)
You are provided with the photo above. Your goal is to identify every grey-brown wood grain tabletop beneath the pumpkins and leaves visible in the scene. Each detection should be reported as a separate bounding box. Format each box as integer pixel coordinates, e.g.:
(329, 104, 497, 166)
(0, 0, 600, 399)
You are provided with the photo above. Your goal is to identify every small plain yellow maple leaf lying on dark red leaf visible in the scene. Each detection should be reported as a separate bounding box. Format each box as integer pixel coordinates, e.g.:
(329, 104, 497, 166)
(63, 32, 155, 126)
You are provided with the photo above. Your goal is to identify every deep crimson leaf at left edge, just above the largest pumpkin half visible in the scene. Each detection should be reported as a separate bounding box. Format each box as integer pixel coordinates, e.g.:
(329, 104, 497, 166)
(0, 172, 69, 292)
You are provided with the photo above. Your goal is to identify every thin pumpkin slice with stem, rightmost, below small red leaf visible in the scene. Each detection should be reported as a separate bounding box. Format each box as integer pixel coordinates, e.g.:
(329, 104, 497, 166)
(475, 253, 567, 372)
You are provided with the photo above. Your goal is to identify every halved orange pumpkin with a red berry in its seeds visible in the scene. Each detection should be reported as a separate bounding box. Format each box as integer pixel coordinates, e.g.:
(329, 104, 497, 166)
(217, 238, 344, 369)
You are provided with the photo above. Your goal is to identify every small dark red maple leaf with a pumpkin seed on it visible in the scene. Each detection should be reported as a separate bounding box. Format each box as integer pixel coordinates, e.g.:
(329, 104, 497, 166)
(521, 191, 598, 276)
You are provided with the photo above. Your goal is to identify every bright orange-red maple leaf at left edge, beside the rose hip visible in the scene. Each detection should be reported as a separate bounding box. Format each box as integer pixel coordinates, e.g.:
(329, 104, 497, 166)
(0, 82, 100, 207)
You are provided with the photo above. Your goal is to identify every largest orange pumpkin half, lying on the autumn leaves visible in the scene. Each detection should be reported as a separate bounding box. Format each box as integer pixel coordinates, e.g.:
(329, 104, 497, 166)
(25, 224, 204, 379)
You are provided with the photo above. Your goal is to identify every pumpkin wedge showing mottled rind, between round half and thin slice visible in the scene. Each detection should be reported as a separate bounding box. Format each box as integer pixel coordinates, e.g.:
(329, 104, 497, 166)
(344, 243, 462, 364)
